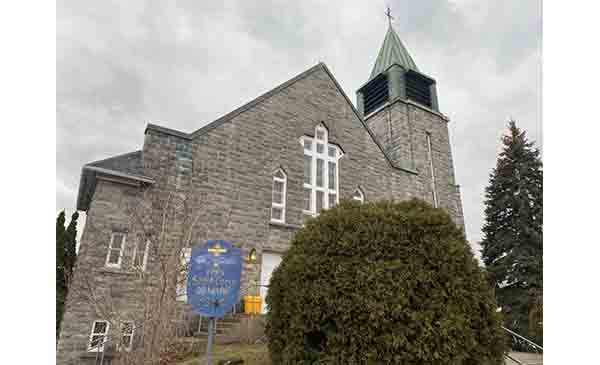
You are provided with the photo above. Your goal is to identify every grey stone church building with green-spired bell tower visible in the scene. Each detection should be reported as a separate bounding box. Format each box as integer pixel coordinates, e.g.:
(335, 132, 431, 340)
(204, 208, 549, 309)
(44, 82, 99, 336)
(57, 26, 464, 364)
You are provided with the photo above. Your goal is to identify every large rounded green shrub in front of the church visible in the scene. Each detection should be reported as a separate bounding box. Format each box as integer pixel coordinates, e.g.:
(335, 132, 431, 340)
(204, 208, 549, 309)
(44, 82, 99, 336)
(266, 200, 505, 365)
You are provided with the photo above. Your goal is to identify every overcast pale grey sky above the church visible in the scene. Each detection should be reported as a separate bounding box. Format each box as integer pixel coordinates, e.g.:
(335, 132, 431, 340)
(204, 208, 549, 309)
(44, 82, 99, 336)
(56, 0, 542, 256)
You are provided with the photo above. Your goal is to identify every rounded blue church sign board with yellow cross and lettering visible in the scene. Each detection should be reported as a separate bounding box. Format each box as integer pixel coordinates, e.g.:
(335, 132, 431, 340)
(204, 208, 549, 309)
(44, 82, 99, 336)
(187, 240, 242, 317)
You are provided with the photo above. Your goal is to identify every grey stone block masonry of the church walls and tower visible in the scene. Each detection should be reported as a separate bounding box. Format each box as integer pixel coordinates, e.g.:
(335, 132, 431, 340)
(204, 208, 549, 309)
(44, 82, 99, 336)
(57, 64, 464, 364)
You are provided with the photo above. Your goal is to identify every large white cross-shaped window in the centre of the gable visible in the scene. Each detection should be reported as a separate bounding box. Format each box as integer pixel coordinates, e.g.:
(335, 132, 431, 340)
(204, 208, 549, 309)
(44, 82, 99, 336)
(300, 125, 343, 216)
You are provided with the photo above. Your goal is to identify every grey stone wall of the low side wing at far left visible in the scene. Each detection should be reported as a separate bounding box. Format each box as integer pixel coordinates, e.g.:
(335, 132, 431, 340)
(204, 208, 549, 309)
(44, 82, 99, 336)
(57, 180, 148, 364)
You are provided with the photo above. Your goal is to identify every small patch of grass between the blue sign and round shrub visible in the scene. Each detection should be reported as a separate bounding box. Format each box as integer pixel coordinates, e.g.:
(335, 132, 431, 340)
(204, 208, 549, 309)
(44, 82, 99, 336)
(178, 344, 271, 365)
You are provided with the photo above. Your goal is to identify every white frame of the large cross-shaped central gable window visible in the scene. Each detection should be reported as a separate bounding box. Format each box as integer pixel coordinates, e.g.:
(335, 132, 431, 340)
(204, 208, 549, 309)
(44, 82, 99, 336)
(300, 124, 344, 217)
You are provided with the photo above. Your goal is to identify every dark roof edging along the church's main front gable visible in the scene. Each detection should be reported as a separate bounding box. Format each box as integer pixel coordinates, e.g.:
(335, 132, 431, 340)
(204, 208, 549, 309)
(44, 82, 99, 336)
(144, 62, 417, 174)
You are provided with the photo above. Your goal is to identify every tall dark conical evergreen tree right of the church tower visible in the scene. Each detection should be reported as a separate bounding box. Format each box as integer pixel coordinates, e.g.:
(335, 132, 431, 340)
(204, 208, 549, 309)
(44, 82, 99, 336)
(481, 120, 543, 344)
